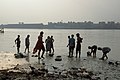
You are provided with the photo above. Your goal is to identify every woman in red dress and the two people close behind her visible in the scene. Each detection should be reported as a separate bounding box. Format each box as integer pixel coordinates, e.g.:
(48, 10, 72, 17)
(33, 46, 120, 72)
(33, 31, 54, 59)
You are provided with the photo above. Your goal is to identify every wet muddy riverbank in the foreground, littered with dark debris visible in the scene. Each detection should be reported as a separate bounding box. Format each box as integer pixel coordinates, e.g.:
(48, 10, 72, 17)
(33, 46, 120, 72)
(0, 52, 120, 80)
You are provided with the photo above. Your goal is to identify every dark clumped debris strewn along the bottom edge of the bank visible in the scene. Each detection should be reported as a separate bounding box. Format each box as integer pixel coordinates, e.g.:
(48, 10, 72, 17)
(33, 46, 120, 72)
(0, 64, 100, 80)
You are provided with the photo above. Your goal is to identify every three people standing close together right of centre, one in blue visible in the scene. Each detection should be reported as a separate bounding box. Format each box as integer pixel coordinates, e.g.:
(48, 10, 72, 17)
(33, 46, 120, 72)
(67, 33, 83, 58)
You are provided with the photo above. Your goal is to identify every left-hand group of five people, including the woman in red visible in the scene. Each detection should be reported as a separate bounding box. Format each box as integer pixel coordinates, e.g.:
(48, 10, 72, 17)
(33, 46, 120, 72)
(15, 31, 54, 59)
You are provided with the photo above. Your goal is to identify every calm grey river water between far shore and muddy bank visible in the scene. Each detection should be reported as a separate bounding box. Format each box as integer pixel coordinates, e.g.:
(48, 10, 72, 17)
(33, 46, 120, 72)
(0, 29, 120, 60)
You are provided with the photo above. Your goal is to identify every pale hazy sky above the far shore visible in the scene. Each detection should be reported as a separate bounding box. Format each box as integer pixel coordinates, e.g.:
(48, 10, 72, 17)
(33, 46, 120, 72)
(0, 0, 120, 24)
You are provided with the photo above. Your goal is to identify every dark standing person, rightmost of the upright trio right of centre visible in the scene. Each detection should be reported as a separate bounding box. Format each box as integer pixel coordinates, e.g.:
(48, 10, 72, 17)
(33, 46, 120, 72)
(76, 33, 83, 58)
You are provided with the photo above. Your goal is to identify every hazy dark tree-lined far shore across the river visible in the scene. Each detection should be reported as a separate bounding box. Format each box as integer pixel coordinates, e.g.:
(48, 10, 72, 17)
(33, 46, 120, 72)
(0, 22, 120, 30)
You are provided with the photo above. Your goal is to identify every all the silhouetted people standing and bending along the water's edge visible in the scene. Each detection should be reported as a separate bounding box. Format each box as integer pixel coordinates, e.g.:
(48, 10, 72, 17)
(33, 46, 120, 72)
(15, 31, 111, 60)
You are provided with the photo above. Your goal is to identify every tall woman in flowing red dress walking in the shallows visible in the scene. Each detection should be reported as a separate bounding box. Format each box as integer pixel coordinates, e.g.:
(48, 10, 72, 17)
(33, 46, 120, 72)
(33, 31, 45, 59)
